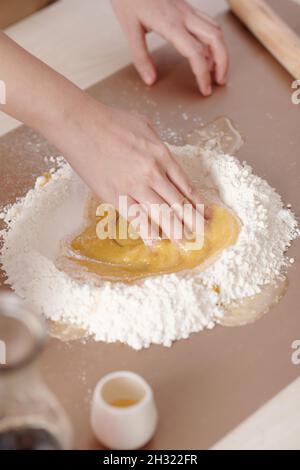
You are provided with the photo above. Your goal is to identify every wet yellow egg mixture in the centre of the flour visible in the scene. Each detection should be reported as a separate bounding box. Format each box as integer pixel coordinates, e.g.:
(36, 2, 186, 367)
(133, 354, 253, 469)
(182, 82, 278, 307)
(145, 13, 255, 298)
(69, 197, 240, 282)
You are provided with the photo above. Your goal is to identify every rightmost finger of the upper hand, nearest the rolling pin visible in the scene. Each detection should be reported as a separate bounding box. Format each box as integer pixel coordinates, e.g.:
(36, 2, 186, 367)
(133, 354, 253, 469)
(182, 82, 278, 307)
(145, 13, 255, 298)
(186, 14, 228, 85)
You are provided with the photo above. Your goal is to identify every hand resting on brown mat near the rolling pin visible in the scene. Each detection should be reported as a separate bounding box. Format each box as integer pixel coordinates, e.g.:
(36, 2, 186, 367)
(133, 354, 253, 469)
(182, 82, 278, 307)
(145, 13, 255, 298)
(112, 0, 228, 96)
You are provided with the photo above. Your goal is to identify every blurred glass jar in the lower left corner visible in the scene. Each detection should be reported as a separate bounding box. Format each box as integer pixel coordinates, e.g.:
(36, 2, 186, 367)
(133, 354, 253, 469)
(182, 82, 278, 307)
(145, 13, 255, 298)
(0, 292, 72, 450)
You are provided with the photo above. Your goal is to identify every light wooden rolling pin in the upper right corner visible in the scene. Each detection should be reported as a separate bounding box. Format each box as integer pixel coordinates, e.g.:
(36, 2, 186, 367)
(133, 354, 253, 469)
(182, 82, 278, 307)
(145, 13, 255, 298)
(228, 0, 300, 79)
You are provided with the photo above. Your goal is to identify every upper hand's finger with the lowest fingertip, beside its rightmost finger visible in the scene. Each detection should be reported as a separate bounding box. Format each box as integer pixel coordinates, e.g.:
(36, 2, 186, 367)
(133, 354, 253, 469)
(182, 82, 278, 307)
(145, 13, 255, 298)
(163, 26, 212, 96)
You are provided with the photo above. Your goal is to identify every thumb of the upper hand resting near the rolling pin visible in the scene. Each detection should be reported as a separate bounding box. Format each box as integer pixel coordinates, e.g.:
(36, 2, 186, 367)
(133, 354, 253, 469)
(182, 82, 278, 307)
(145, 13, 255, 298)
(127, 23, 156, 85)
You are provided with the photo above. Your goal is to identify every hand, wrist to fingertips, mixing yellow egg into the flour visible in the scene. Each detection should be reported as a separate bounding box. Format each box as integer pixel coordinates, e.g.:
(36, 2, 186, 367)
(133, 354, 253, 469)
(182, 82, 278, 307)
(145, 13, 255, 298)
(59, 99, 203, 241)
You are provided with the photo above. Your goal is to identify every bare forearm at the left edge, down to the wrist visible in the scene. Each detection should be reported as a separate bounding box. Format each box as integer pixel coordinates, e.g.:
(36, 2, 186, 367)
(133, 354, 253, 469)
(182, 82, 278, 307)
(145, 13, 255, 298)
(0, 32, 95, 143)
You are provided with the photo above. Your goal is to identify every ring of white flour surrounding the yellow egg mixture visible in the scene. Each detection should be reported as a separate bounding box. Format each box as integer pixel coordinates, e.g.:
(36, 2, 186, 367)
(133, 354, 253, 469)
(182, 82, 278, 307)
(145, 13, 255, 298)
(1, 146, 299, 349)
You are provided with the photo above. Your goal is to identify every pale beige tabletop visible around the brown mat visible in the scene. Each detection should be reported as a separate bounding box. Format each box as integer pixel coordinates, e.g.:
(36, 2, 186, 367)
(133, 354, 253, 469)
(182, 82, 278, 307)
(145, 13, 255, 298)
(0, 0, 300, 449)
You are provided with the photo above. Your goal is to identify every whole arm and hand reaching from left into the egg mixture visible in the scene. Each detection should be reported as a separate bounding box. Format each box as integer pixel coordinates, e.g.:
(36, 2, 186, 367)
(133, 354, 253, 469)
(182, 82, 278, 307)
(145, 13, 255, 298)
(0, 32, 203, 239)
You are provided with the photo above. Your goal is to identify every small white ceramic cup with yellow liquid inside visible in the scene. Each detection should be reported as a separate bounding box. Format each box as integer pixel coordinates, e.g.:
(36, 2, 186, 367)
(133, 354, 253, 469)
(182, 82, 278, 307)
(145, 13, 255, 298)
(91, 371, 157, 450)
